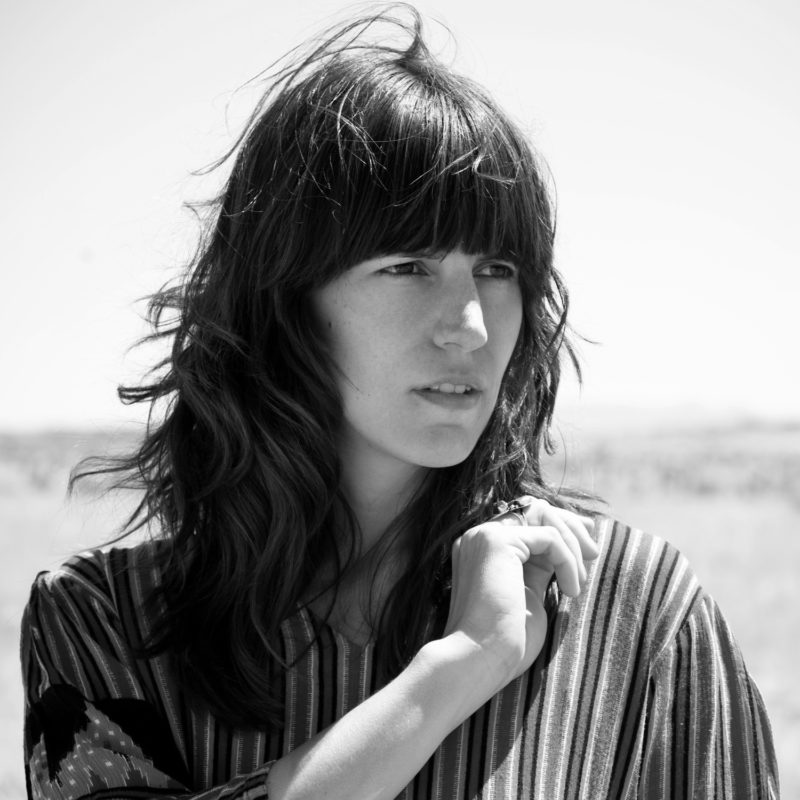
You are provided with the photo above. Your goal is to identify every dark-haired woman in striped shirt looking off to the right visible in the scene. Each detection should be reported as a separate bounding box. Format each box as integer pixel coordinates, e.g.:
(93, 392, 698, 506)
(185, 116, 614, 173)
(22, 7, 777, 800)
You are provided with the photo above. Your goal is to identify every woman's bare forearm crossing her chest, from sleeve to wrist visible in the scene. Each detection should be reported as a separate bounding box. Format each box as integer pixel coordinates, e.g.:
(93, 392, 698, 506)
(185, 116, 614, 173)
(267, 636, 502, 800)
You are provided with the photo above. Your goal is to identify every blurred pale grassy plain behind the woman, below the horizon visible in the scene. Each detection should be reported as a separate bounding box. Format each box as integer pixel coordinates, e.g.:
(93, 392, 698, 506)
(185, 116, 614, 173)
(0, 419, 800, 798)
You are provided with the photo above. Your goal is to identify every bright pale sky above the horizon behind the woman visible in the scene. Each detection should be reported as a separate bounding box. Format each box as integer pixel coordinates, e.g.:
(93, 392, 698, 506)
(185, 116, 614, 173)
(0, 0, 800, 430)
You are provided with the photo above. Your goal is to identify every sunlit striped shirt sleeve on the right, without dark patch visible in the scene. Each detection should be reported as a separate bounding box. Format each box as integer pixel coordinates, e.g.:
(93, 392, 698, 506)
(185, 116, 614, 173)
(638, 594, 779, 800)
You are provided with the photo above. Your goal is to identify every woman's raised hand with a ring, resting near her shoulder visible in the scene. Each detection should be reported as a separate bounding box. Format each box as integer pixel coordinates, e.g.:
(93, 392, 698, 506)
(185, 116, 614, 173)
(444, 495, 599, 689)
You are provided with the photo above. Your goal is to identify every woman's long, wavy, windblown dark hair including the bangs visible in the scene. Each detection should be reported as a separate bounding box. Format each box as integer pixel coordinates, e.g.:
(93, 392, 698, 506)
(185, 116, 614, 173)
(71, 4, 578, 726)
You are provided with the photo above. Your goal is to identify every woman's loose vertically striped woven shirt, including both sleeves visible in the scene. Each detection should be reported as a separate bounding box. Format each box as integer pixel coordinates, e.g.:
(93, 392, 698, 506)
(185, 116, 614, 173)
(22, 519, 778, 800)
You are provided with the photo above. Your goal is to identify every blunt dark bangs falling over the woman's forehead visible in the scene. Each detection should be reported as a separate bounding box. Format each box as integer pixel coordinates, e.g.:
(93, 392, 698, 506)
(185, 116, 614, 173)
(322, 59, 549, 266)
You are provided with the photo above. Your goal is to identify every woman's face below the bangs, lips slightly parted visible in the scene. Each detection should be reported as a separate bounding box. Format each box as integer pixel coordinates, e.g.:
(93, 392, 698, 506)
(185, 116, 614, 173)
(312, 250, 522, 478)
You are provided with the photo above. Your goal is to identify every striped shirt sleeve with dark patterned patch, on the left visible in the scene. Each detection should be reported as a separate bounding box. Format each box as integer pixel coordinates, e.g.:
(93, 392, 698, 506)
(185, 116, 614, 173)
(21, 572, 273, 800)
